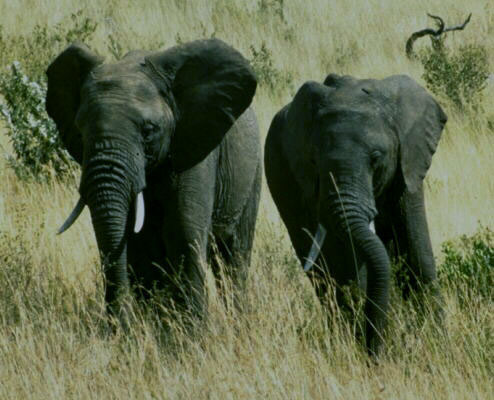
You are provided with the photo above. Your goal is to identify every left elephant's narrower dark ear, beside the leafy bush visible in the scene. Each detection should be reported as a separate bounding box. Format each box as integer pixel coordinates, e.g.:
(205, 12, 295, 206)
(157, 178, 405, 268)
(46, 43, 103, 164)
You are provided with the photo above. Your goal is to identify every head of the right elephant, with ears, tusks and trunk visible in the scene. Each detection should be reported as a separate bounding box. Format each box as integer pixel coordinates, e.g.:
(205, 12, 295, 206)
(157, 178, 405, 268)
(278, 74, 447, 352)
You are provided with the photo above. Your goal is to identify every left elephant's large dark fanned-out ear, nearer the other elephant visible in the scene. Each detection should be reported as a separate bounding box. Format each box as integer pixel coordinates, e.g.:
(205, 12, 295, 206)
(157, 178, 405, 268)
(146, 39, 257, 171)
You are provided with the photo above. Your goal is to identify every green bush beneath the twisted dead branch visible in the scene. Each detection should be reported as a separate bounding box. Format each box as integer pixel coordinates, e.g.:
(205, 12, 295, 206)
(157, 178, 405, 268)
(420, 44, 489, 108)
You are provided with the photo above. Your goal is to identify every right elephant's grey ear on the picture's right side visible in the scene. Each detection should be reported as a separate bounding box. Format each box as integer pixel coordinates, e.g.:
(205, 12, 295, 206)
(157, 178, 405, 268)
(388, 75, 448, 192)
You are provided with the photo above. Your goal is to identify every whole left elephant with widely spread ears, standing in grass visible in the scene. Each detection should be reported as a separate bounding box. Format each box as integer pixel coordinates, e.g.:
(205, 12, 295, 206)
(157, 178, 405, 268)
(46, 39, 262, 316)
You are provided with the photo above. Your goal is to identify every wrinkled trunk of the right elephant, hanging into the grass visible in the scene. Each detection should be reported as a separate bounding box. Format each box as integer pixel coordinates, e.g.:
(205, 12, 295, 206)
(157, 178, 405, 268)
(323, 195, 391, 355)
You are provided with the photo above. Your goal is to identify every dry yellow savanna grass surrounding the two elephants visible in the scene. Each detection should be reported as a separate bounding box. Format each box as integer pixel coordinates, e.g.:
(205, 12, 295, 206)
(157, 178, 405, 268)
(0, 0, 494, 399)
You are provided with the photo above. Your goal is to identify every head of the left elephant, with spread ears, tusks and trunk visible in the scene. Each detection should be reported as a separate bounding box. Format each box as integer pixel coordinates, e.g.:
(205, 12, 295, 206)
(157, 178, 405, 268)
(46, 39, 256, 311)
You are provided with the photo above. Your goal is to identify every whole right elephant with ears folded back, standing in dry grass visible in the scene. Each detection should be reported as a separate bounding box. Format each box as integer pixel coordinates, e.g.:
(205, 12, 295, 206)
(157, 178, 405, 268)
(265, 74, 447, 355)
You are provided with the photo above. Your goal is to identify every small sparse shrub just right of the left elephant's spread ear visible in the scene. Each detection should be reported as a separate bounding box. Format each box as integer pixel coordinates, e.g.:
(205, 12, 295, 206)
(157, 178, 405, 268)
(250, 42, 293, 93)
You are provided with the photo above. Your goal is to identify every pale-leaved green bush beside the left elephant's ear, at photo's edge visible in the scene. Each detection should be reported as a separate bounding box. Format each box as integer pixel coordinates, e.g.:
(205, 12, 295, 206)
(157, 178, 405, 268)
(0, 62, 75, 181)
